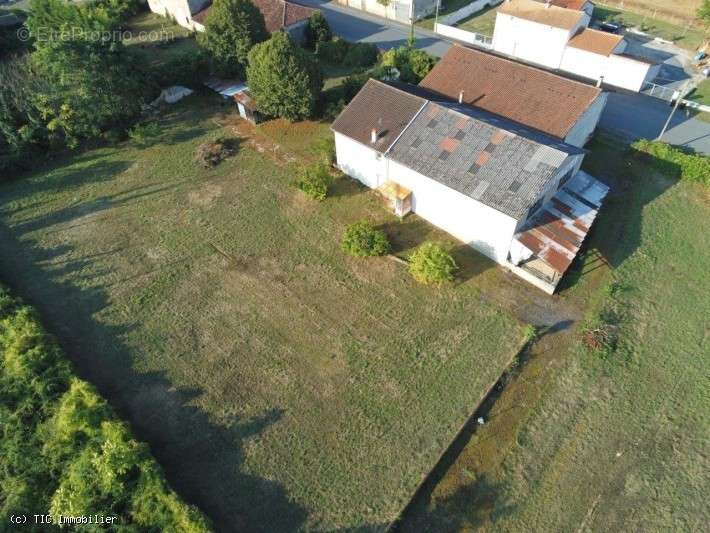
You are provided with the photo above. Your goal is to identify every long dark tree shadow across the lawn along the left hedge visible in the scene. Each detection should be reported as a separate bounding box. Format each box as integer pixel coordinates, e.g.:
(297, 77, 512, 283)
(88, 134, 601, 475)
(0, 185, 308, 532)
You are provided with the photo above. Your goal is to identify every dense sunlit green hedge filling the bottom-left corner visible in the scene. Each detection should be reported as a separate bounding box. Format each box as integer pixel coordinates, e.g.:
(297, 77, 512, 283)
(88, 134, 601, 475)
(0, 286, 210, 532)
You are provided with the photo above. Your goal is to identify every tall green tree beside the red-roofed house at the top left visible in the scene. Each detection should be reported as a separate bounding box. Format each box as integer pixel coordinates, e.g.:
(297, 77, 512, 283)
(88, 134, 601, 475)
(197, 0, 269, 78)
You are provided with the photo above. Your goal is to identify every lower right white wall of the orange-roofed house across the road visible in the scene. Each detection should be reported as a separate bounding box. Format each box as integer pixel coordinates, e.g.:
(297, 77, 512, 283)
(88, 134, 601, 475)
(560, 47, 655, 91)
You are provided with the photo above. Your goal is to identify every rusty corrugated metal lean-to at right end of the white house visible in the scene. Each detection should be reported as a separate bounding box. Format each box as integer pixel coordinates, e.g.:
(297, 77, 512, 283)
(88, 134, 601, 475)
(511, 171, 609, 285)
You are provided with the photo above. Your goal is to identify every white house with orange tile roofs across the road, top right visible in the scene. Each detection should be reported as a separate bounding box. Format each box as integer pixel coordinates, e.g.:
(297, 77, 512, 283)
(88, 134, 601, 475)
(493, 0, 660, 91)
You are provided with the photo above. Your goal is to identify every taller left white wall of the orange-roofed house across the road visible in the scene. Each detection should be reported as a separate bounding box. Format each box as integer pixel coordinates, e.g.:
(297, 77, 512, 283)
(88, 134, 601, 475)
(493, 12, 572, 69)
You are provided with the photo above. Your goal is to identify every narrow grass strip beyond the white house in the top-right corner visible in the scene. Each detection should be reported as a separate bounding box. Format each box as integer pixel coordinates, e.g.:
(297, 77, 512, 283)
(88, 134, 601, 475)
(594, 5, 710, 51)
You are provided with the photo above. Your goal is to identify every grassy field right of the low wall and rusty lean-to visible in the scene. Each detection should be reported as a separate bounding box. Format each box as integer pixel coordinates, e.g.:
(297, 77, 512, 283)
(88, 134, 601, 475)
(400, 132, 710, 532)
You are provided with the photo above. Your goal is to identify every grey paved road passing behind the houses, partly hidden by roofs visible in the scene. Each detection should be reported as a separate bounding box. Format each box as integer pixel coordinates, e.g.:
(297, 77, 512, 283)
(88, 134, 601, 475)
(306, 0, 710, 154)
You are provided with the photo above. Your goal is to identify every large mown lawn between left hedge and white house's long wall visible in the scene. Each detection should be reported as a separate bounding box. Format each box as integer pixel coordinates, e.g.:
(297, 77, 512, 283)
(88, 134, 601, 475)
(0, 95, 521, 531)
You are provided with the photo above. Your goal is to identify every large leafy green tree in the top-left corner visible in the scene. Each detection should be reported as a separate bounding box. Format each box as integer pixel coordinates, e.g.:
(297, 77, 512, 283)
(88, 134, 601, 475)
(27, 0, 145, 146)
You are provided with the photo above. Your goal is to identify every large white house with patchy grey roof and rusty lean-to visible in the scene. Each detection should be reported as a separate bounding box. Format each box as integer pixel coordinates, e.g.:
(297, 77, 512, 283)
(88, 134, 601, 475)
(332, 80, 607, 293)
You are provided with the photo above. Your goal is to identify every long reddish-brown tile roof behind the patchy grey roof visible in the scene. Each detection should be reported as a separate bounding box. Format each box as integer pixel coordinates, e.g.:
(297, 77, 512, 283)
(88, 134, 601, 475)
(419, 46, 601, 139)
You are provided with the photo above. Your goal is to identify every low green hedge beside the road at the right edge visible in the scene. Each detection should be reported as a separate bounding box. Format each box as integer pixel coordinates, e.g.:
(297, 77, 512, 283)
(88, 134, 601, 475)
(631, 139, 710, 186)
